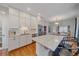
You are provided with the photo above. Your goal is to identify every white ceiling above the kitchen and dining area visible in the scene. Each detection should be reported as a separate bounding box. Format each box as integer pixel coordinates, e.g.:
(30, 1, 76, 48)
(1, 3, 77, 21)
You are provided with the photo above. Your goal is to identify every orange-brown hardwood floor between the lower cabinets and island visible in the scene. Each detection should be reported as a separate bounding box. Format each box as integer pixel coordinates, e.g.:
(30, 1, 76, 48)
(8, 42, 36, 56)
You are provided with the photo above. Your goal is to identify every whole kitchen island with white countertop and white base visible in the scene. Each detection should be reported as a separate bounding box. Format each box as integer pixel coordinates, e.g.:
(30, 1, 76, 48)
(33, 35, 63, 56)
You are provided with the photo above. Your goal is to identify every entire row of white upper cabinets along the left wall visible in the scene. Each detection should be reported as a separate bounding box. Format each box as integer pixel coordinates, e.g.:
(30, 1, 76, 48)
(8, 8, 38, 34)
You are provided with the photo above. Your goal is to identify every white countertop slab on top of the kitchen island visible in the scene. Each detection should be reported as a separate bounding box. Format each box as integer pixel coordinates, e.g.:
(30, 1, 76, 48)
(33, 35, 63, 51)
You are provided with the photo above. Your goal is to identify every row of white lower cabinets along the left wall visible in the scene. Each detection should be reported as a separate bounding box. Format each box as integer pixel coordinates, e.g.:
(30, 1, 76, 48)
(8, 35, 32, 51)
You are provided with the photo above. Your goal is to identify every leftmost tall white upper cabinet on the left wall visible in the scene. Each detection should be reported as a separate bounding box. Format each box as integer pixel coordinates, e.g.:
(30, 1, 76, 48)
(8, 8, 19, 28)
